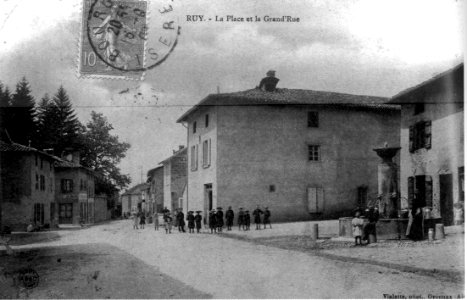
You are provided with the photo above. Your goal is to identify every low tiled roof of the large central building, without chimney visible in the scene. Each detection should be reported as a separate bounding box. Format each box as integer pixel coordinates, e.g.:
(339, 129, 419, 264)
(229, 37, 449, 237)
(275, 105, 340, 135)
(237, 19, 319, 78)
(177, 89, 400, 122)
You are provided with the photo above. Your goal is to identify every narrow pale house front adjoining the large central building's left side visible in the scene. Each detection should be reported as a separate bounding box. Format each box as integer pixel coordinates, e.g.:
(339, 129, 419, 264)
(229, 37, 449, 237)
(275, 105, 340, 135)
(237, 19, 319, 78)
(160, 146, 187, 211)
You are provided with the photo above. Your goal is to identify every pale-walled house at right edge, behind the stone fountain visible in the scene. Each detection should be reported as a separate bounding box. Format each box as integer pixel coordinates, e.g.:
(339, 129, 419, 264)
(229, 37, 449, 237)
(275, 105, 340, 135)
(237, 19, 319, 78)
(389, 64, 464, 225)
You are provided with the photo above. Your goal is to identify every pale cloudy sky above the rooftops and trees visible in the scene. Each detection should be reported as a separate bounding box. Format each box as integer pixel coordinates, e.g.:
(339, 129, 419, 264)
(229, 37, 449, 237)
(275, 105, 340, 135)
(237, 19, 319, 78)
(0, 0, 465, 184)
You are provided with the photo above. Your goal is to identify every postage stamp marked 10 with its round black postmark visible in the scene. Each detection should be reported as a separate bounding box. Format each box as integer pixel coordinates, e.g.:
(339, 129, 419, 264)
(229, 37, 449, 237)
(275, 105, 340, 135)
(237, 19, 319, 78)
(78, 0, 180, 80)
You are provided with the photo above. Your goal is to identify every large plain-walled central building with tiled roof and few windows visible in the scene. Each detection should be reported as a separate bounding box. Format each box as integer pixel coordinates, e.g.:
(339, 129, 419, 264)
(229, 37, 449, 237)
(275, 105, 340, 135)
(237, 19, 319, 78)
(177, 89, 400, 221)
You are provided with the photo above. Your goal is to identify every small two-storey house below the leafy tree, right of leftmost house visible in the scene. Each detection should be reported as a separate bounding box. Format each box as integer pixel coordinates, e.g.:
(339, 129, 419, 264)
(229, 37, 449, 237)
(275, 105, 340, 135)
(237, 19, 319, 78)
(55, 151, 96, 224)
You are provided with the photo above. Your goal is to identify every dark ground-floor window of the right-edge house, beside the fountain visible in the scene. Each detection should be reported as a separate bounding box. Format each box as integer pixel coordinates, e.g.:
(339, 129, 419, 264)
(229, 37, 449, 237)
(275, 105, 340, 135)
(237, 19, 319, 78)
(408, 175, 433, 207)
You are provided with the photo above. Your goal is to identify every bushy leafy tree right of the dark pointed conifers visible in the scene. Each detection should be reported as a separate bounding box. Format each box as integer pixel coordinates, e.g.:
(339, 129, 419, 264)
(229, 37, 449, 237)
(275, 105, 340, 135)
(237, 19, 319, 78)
(81, 111, 131, 195)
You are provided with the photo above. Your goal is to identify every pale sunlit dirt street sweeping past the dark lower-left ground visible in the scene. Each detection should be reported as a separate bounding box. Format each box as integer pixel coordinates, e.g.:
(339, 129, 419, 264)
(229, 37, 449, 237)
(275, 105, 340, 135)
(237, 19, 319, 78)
(2, 220, 463, 298)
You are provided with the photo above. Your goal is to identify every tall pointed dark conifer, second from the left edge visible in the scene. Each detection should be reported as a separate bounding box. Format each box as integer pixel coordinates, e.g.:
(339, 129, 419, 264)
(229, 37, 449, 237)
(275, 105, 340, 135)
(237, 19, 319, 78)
(6, 77, 36, 145)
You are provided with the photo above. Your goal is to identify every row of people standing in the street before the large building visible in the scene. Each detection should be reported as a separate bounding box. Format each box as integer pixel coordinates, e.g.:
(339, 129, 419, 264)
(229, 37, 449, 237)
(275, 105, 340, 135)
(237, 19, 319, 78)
(133, 205, 272, 234)
